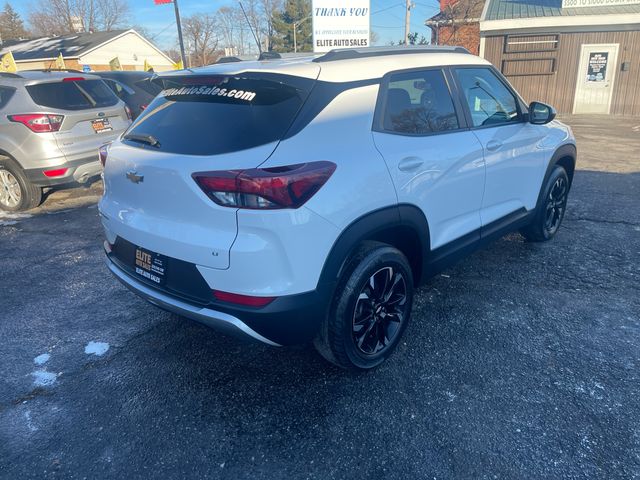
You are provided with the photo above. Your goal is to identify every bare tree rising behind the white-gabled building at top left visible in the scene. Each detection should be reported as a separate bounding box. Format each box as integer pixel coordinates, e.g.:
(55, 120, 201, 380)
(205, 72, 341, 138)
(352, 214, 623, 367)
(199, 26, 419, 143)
(29, 0, 129, 35)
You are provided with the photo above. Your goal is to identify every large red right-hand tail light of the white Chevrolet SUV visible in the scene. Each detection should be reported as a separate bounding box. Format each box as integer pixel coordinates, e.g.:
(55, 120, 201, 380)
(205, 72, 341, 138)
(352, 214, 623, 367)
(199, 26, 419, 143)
(192, 162, 336, 210)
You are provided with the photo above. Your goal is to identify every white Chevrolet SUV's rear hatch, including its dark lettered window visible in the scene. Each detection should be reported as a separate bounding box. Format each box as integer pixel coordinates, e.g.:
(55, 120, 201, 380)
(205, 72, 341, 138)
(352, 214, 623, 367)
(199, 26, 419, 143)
(100, 72, 317, 269)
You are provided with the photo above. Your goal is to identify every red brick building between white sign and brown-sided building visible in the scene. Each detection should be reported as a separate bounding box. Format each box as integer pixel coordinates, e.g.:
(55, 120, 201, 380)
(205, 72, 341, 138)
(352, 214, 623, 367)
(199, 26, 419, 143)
(425, 0, 484, 55)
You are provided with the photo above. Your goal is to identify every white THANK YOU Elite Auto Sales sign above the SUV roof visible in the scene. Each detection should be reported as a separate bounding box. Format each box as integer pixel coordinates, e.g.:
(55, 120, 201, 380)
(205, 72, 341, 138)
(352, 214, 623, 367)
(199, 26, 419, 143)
(311, 0, 370, 52)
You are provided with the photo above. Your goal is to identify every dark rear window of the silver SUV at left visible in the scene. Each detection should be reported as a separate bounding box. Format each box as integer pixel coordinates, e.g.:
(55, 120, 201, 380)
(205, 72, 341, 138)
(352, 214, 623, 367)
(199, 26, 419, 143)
(26, 80, 118, 110)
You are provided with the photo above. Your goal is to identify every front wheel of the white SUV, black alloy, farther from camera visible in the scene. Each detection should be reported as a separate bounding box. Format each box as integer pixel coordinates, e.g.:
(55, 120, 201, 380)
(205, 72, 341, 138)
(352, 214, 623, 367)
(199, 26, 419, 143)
(520, 165, 569, 242)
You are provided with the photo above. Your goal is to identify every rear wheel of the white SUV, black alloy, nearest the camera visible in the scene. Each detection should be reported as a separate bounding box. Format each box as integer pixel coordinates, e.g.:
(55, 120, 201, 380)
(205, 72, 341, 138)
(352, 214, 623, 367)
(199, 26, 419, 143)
(314, 242, 414, 370)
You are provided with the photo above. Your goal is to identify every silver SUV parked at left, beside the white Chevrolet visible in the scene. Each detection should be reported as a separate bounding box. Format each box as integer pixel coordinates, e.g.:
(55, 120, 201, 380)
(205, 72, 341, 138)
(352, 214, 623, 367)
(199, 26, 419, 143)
(0, 71, 131, 211)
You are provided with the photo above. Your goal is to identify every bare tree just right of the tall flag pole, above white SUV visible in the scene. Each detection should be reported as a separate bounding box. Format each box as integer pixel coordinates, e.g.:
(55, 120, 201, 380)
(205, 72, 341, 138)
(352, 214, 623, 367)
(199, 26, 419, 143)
(182, 13, 220, 66)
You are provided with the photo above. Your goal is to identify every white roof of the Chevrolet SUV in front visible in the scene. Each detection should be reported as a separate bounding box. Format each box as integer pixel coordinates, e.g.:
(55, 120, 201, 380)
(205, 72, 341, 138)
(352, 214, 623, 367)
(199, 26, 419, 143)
(152, 46, 490, 82)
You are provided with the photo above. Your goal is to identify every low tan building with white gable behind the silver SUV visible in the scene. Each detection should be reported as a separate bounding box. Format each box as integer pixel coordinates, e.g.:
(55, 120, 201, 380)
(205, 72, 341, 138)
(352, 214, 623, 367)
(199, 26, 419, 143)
(0, 30, 173, 72)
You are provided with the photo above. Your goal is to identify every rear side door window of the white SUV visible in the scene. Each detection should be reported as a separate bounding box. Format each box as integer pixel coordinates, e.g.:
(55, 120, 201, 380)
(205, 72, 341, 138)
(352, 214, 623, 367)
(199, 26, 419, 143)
(382, 70, 459, 135)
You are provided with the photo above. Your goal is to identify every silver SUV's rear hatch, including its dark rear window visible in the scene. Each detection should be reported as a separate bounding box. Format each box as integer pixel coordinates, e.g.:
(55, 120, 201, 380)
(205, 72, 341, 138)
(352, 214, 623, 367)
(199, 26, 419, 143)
(26, 77, 130, 161)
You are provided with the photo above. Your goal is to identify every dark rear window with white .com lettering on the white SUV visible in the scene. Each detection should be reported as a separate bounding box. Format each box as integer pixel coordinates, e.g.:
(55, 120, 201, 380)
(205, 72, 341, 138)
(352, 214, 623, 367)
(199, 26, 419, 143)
(123, 73, 315, 155)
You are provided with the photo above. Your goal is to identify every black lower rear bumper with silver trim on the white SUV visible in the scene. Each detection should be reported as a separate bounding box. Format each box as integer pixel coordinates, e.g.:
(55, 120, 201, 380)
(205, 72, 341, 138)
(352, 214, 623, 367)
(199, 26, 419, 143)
(106, 253, 332, 346)
